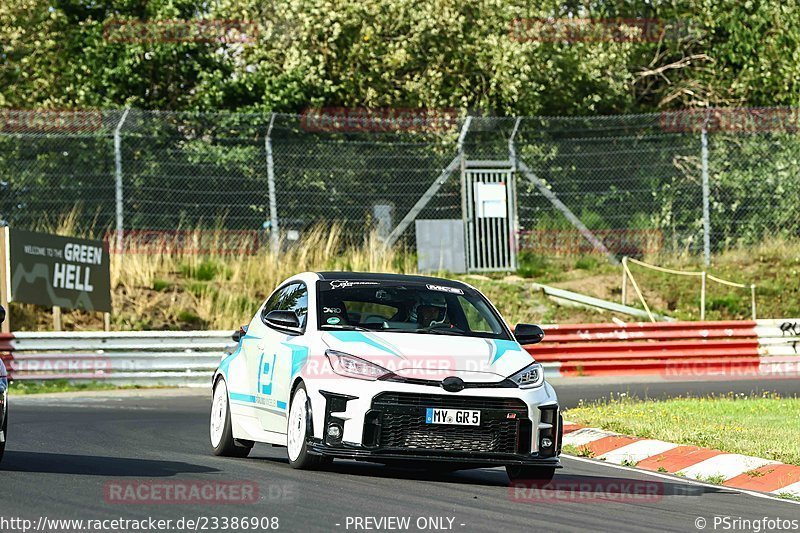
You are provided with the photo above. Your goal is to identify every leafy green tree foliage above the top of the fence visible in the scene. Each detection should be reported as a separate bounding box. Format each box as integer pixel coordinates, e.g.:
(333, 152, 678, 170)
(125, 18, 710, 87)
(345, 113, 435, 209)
(0, 0, 800, 115)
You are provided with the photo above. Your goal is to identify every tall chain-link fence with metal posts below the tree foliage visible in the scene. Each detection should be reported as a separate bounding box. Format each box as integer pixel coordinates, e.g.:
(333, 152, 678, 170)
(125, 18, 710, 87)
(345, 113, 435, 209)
(0, 105, 800, 255)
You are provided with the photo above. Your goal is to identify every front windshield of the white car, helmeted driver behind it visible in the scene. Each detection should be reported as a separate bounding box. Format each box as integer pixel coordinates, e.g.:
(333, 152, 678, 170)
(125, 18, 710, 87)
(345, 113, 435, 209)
(317, 280, 510, 339)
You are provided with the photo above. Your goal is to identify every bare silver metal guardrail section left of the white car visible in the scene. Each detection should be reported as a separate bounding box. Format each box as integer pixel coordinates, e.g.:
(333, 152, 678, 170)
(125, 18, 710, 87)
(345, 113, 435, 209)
(0, 330, 235, 386)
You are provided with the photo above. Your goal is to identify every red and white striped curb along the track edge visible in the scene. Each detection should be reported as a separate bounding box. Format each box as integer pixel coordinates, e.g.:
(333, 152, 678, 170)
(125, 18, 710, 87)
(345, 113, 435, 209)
(563, 422, 800, 497)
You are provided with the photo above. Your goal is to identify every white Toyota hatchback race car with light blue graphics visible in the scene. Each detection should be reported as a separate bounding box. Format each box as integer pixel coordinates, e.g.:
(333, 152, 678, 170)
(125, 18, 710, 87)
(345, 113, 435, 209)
(210, 272, 562, 480)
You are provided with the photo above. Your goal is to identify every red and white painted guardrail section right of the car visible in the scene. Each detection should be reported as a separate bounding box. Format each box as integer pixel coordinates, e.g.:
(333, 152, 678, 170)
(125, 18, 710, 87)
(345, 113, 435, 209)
(526, 319, 800, 378)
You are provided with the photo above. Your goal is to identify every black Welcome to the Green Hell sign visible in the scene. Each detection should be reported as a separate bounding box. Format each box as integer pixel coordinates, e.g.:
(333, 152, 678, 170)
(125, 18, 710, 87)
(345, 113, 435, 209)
(9, 229, 111, 311)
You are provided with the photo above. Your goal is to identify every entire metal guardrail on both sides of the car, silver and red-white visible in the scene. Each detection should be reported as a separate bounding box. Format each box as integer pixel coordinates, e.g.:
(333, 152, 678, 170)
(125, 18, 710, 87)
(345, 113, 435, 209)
(0, 319, 800, 386)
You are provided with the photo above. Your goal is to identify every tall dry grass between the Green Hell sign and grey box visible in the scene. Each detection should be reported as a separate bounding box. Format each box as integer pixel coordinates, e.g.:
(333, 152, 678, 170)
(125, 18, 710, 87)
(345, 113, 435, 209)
(111, 225, 416, 329)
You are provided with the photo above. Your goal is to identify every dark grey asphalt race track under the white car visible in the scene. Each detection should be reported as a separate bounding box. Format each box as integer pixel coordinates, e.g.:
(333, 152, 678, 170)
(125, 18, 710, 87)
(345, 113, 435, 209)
(0, 380, 800, 532)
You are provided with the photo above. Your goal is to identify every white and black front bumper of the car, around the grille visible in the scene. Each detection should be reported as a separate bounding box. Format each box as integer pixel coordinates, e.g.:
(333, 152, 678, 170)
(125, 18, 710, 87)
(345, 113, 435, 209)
(306, 380, 562, 467)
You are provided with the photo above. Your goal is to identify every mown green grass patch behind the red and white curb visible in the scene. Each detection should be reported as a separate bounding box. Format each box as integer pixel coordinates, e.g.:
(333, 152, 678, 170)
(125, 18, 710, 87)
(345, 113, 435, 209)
(564, 394, 800, 466)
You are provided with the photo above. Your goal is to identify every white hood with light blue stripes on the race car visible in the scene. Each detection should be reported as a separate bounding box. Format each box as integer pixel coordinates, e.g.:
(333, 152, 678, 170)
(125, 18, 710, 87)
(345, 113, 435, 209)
(322, 331, 533, 383)
